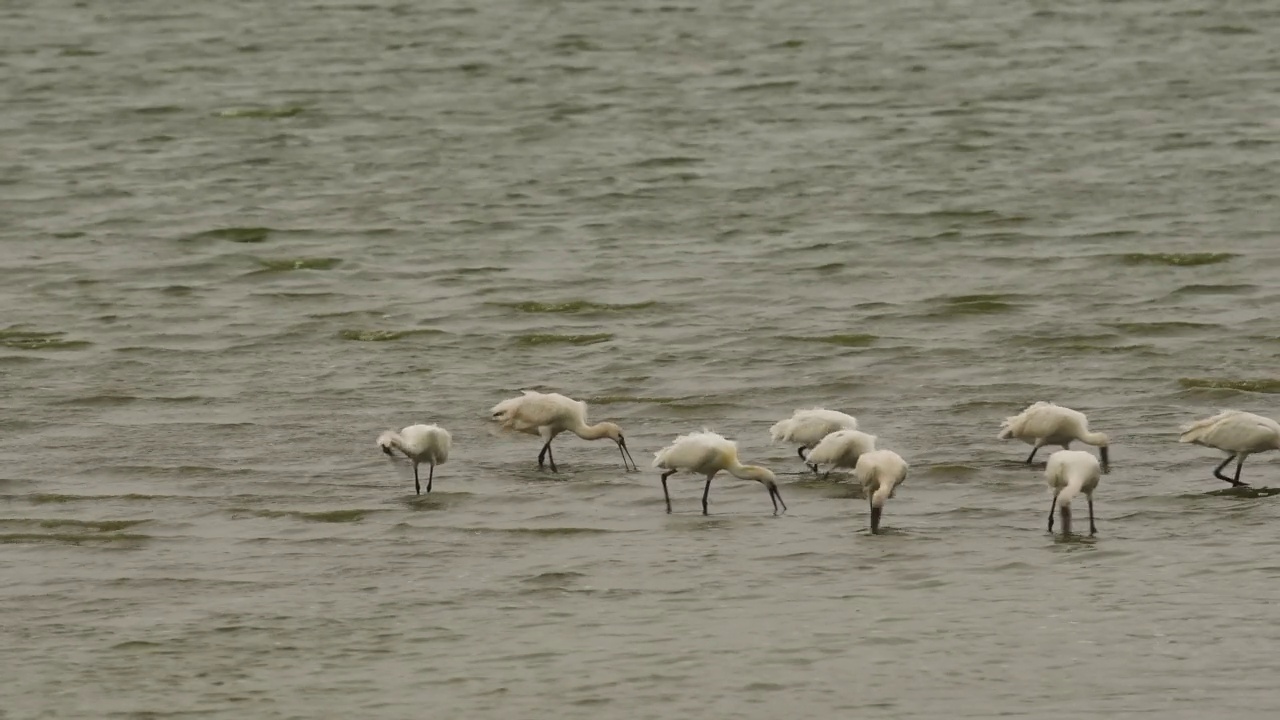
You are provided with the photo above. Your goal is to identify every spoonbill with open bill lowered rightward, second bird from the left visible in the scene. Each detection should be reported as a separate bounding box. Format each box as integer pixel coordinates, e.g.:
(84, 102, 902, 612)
(490, 389, 640, 473)
